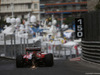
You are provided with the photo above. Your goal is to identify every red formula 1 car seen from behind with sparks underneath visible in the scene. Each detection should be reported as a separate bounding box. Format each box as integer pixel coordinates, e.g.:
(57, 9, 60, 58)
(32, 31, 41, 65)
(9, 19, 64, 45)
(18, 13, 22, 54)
(16, 47, 54, 68)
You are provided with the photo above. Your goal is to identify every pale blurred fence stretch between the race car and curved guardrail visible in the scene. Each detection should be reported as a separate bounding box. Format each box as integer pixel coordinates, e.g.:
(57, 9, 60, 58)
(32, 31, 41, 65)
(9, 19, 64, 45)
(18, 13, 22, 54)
(41, 44, 80, 58)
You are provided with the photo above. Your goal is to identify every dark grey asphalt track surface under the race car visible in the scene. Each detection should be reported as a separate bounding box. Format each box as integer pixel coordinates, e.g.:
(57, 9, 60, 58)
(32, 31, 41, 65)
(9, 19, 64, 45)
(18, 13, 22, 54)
(0, 58, 100, 75)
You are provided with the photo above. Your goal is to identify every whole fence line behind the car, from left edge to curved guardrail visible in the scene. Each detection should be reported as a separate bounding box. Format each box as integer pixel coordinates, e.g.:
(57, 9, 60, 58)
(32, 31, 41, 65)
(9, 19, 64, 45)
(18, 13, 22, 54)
(0, 34, 79, 59)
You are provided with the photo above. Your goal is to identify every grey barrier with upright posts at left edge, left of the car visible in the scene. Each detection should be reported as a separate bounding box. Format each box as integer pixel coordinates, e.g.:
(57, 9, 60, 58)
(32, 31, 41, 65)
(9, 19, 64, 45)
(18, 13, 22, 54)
(0, 34, 40, 58)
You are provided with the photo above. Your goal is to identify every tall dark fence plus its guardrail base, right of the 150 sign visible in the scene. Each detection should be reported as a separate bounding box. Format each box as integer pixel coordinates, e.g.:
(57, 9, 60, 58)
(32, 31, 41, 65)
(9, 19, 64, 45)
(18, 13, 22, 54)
(82, 11, 100, 64)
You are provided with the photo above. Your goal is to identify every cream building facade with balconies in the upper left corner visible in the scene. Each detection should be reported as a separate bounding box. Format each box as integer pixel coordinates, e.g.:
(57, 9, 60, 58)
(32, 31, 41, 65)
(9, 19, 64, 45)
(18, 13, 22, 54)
(0, 0, 40, 20)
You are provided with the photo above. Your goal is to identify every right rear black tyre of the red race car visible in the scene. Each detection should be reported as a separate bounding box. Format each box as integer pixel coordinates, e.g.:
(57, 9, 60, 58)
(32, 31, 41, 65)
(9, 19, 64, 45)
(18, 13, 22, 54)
(45, 54, 54, 67)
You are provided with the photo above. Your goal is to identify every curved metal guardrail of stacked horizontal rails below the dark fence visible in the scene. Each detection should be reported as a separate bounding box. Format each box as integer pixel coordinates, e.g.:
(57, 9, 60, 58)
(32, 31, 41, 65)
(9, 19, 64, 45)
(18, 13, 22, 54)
(82, 41, 100, 64)
